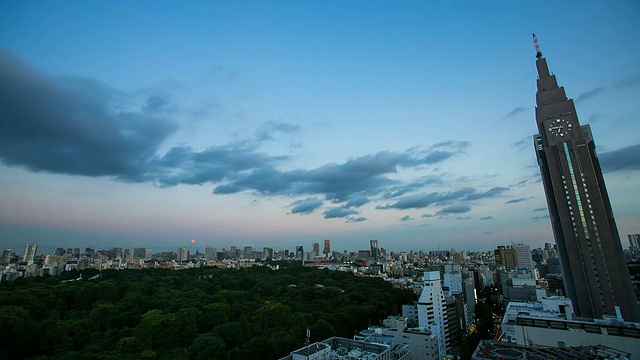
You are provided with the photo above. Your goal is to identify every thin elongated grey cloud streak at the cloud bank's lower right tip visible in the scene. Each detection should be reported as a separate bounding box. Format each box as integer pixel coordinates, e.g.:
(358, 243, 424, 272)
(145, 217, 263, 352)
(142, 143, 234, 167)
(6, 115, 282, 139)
(376, 187, 509, 210)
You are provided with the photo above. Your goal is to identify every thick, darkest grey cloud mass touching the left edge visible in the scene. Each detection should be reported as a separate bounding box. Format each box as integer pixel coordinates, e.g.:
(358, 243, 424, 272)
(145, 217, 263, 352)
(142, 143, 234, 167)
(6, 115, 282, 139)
(0, 50, 177, 180)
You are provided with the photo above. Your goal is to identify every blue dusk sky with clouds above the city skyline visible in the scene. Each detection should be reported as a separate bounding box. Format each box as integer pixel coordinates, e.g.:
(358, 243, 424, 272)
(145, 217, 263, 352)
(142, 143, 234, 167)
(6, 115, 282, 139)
(0, 0, 640, 253)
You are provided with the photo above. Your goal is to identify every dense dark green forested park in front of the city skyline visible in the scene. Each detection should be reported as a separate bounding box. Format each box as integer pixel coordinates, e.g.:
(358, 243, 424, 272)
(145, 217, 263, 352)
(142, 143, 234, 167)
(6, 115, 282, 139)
(0, 265, 416, 359)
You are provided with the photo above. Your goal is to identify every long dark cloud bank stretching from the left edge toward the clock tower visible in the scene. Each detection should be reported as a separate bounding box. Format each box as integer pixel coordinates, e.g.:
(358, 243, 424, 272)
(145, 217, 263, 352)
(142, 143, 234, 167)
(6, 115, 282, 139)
(0, 50, 480, 222)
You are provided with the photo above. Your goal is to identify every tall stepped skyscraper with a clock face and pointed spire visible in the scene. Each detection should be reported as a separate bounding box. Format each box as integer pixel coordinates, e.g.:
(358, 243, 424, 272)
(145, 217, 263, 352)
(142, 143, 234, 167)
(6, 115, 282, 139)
(534, 41, 640, 321)
